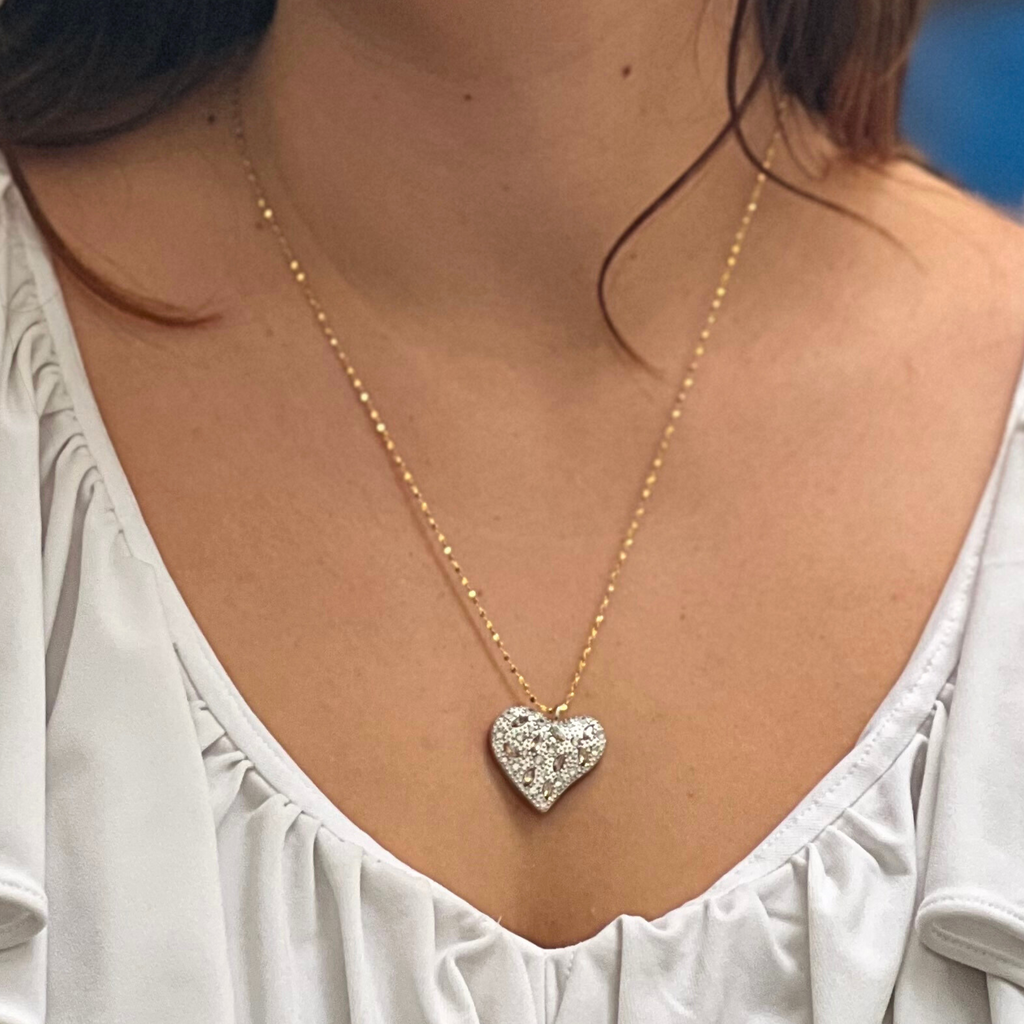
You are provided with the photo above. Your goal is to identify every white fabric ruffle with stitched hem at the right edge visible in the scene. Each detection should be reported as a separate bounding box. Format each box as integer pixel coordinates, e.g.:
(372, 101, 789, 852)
(916, 417, 1024, 991)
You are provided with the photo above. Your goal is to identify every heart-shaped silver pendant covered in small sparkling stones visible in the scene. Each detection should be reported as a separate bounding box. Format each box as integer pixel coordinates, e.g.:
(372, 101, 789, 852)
(490, 707, 605, 812)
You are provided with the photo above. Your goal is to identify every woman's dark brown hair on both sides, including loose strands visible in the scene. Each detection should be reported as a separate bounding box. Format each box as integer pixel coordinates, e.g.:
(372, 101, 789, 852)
(0, 0, 926, 333)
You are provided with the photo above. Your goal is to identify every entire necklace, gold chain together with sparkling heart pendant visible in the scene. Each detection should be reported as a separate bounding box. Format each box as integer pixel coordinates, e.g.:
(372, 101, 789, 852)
(233, 84, 779, 812)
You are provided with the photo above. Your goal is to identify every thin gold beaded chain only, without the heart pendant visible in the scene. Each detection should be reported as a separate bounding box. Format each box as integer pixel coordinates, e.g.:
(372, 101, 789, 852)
(234, 88, 779, 718)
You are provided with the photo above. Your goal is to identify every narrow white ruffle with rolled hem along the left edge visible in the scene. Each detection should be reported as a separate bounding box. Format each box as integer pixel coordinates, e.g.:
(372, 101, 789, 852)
(0, 159, 47, 1021)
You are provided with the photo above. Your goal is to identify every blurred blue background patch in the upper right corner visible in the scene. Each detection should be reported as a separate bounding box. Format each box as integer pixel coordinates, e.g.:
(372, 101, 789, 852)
(902, 0, 1024, 209)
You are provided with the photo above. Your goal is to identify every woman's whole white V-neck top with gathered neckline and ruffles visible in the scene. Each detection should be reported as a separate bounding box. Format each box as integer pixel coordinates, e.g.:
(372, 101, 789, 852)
(0, 151, 1024, 1024)
